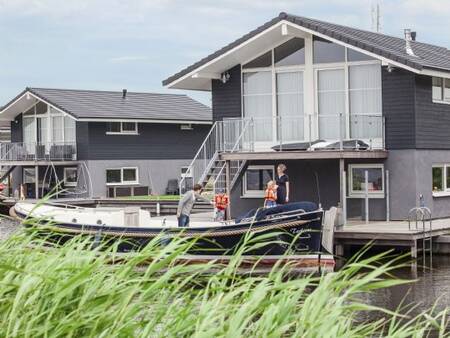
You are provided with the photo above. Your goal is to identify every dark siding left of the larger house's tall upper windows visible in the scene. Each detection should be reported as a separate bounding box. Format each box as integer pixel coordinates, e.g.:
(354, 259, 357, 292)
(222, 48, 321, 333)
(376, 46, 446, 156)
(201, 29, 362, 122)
(212, 65, 241, 121)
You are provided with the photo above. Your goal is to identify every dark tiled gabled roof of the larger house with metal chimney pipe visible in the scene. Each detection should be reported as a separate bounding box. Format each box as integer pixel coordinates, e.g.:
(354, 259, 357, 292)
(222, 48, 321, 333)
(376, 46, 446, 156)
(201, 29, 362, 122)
(163, 12, 450, 87)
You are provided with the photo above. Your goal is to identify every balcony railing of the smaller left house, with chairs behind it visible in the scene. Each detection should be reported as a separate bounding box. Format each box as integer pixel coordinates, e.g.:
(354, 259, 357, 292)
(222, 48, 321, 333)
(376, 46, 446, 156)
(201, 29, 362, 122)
(0, 142, 77, 161)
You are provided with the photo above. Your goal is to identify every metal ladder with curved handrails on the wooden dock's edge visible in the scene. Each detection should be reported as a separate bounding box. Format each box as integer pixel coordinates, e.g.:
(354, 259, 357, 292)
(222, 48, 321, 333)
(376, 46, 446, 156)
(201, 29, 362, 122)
(408, 206, 433, 267)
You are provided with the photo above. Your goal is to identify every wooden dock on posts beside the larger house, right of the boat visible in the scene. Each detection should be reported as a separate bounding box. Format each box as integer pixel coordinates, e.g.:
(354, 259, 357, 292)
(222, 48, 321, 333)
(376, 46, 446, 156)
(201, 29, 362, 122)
(334, 218, 450, 258)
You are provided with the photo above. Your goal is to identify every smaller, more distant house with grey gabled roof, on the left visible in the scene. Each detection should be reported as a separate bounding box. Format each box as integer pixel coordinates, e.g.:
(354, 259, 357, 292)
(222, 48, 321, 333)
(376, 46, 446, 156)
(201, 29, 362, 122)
(0, 88, 211, 198)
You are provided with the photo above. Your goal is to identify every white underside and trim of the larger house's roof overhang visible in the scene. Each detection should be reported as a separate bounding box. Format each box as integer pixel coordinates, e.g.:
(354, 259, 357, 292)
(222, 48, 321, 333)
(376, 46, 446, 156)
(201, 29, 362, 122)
(163, 20, 450, 91)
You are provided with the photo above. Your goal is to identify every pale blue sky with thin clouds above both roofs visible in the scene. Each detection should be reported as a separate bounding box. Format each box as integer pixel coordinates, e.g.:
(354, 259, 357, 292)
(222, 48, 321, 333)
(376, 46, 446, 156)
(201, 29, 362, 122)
(0, 0, 450, 106)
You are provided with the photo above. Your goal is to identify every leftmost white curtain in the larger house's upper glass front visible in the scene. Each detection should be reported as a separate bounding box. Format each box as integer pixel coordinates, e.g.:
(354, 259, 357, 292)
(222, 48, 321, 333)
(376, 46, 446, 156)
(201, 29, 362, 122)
(243, 71, 273, 141)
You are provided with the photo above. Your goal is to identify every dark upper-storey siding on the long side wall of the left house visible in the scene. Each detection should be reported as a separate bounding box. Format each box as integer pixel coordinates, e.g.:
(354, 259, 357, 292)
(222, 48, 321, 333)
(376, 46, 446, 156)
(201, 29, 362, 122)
(88, 122, 211, 160)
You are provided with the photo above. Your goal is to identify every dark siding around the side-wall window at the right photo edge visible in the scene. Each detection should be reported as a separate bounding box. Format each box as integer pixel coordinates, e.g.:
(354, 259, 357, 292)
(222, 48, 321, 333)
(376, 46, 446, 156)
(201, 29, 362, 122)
(416, 75, 450, 149)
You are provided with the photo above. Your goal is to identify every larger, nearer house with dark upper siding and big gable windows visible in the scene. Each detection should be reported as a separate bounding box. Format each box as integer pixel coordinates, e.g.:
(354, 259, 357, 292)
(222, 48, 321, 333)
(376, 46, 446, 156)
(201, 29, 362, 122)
(163, 13, 450, 220)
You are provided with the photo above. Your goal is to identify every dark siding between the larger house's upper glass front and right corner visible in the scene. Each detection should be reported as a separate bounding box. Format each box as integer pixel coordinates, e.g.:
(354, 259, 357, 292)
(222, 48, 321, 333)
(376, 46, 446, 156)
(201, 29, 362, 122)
(382, 67, 416, 149)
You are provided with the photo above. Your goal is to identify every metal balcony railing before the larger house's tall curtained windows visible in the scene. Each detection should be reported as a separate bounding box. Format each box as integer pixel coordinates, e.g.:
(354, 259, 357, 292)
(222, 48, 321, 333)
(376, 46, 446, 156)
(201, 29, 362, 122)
(221, 114, 385, 152)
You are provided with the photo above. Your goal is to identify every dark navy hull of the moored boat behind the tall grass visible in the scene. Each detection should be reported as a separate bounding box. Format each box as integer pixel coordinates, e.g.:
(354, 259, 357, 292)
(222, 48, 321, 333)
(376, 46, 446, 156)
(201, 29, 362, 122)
(15, 203, 323, 255)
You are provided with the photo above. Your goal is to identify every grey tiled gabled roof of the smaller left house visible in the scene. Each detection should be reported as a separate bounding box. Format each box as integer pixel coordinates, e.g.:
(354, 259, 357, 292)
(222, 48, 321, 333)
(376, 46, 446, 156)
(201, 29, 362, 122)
(0, 88, 212, 123)
